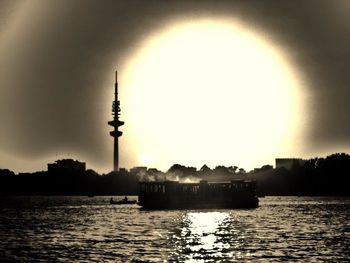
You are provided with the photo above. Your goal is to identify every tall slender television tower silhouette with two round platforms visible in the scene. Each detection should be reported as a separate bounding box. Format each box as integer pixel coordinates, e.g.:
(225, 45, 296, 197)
(108, 71, 124, 172)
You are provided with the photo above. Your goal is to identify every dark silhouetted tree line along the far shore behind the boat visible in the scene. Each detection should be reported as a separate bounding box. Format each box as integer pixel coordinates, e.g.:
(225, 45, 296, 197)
(0, 153, 350, 196)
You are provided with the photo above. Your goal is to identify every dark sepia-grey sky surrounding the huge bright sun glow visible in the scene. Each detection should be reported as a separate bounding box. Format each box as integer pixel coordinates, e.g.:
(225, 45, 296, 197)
(0, 0, 350, 172)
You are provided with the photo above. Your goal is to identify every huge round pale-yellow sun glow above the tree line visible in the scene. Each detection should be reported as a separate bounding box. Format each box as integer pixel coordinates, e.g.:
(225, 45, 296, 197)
(120, 20, 303, 169)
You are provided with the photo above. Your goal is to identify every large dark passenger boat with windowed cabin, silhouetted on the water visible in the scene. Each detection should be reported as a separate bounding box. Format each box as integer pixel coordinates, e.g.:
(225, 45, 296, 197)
(138, 180, 259, 209)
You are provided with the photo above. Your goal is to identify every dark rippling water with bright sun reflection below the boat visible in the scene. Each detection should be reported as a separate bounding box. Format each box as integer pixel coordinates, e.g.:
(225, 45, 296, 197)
(0, 197, 350, 262)
